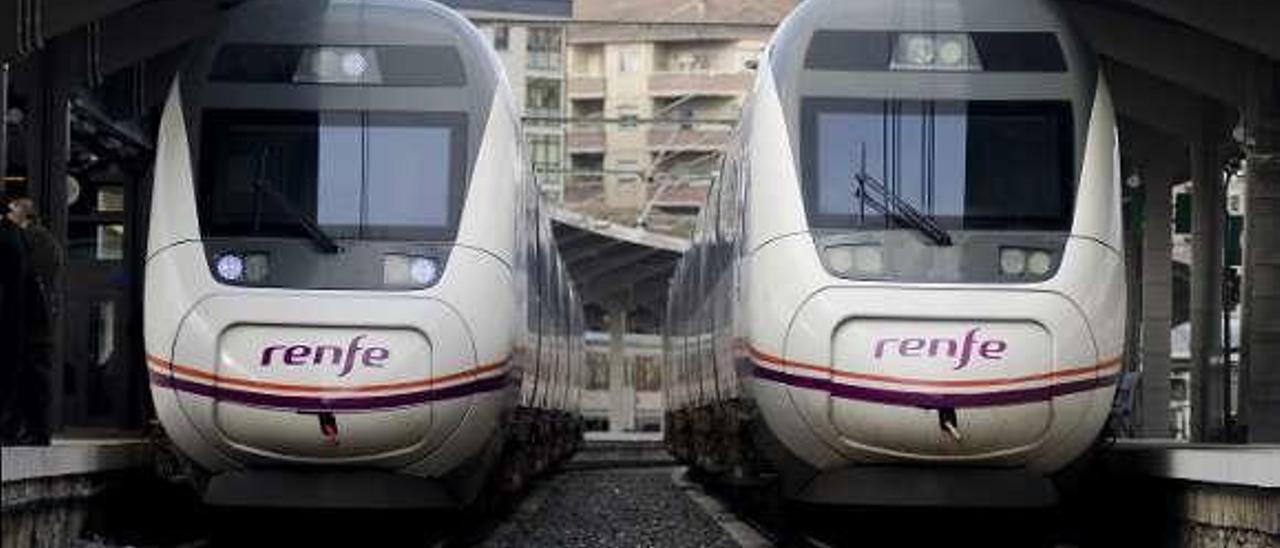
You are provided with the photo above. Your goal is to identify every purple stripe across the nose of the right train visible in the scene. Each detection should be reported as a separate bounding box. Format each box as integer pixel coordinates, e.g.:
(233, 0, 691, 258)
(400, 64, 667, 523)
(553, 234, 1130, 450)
(755, 365, 1116, 408)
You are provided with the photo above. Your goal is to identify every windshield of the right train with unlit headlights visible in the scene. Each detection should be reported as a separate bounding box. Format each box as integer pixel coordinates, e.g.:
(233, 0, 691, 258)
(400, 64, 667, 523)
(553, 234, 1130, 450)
(801, 99, 1074, 233)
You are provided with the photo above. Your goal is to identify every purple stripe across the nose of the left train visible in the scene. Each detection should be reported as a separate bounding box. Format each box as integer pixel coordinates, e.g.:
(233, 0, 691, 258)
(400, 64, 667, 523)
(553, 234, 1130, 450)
(151, 371, 511, 411)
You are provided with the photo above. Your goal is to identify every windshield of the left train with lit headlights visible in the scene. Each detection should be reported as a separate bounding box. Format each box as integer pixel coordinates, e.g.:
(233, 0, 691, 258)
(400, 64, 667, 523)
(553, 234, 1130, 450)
(200, 109, 466, 241)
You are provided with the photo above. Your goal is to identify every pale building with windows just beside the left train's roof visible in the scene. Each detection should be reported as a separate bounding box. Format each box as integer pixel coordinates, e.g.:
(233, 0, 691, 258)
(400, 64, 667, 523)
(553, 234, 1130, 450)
(445, 0, 573, 200)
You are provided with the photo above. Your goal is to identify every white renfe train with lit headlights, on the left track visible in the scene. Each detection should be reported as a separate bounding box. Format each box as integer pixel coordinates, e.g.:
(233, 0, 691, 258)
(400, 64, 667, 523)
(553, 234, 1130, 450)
(145, 0, 584, 507)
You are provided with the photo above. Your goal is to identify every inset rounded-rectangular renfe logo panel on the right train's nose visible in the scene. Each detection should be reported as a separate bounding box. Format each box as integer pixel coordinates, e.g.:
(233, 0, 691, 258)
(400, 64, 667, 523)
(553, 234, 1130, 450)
(831, 319, 1053, 455)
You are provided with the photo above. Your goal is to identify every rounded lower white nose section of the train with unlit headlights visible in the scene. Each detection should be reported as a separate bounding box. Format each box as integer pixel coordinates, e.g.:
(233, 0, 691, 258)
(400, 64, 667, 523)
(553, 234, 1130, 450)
(785, 288, 1107, 460)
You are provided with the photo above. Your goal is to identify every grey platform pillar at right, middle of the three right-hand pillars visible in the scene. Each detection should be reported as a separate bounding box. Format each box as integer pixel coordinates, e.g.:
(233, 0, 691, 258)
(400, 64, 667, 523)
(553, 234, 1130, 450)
(1190, 114, 1226, 442)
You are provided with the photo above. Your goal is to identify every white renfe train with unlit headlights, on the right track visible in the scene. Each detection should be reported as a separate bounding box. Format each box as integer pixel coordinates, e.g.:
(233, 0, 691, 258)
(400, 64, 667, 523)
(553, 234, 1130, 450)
(666, 0, 1125, 506)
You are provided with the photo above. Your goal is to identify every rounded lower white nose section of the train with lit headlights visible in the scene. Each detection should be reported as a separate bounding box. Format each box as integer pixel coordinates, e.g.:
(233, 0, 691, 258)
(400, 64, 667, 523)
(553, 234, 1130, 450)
(161, 296, 481, 465)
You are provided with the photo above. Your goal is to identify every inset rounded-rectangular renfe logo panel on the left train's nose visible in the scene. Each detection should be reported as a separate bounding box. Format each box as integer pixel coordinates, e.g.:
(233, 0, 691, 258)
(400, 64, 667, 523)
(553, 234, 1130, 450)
(214, 325, 433, 458)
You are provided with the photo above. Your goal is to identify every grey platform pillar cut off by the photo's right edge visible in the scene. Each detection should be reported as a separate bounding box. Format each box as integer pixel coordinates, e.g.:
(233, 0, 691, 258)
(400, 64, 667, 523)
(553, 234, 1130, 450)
(1240, 63, 1280, 443)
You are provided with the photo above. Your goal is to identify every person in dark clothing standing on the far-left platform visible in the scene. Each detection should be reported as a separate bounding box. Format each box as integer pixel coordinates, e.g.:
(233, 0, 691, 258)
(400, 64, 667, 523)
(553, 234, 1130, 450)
(4, 197, 52, 446)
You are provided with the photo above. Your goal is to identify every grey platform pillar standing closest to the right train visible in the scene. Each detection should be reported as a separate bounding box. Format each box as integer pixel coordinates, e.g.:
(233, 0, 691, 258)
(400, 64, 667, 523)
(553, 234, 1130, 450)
(1139, 163, 1174, 438)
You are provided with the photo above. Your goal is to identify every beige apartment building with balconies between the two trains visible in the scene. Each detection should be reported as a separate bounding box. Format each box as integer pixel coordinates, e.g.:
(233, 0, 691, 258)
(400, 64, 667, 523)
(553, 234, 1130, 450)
(566, 0, 797, 236)
